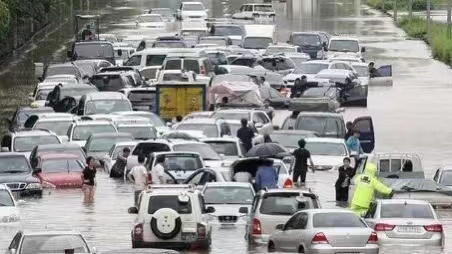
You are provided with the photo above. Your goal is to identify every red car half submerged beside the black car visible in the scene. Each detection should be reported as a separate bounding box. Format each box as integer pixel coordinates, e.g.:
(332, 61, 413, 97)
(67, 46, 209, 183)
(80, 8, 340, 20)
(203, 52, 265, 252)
(34, 153, 84, 188)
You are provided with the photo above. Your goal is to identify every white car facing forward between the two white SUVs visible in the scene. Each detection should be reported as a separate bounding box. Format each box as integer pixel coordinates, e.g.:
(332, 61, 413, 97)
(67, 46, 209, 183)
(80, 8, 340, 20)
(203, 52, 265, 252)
(202, 182, 255, 226)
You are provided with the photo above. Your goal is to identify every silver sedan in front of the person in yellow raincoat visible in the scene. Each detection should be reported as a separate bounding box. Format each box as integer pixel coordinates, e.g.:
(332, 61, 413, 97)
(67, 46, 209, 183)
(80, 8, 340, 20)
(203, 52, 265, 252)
(365, 199, 445, 246)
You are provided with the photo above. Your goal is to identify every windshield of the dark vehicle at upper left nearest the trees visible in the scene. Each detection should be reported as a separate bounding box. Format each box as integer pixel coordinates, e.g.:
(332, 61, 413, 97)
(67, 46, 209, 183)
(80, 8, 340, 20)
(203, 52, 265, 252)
(74, 43, 115, 59)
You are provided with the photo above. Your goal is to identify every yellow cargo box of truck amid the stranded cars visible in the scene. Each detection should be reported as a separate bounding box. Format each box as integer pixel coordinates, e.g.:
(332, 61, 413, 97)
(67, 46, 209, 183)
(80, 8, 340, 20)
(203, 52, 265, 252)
(156, 82, 207, 121)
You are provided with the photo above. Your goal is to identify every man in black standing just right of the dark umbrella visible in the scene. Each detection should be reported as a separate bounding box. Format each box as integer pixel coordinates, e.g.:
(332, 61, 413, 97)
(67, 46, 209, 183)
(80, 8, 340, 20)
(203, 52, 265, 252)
(292, 139, 314, 184)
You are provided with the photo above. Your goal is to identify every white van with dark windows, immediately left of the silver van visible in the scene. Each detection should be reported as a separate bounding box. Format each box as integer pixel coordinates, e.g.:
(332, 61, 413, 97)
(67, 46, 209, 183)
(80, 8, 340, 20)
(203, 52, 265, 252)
(123, 48, 173, 69)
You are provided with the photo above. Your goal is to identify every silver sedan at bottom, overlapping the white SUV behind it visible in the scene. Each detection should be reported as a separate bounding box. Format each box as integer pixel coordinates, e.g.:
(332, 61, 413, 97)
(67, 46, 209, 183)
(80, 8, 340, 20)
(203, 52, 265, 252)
(267, 209, 379, 254)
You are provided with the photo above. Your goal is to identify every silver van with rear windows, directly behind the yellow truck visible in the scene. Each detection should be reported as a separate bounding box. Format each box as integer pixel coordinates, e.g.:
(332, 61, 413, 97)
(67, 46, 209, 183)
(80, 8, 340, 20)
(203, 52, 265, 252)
(162, 49, 214, 77)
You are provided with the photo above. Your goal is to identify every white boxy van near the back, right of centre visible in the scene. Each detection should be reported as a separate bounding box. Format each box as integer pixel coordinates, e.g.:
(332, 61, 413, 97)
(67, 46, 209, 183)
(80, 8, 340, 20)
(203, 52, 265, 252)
(242, 25, 276, 51)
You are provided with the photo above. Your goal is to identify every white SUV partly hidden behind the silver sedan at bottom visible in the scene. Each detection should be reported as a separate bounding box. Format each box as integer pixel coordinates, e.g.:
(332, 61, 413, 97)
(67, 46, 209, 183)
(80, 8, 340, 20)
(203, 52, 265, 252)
(240, 189, 320, 245)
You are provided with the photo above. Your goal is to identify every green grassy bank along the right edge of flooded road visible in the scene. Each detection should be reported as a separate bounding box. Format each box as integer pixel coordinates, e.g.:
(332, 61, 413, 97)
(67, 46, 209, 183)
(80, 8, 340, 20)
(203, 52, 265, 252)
(398, 17, 452, 65)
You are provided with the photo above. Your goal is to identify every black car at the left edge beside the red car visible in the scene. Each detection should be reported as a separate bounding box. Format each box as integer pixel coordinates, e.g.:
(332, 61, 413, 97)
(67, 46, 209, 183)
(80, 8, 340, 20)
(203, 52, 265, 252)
(0, 152, 42, 197)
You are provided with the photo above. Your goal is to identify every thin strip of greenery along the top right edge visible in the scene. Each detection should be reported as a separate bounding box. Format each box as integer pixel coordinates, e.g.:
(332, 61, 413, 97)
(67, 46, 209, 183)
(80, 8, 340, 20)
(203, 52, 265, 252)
(366, 0, 445, 11)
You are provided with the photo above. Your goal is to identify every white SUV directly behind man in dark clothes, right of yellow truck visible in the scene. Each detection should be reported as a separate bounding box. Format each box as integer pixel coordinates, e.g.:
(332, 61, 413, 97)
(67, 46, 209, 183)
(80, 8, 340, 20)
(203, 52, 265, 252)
(211, 109, 273, 135)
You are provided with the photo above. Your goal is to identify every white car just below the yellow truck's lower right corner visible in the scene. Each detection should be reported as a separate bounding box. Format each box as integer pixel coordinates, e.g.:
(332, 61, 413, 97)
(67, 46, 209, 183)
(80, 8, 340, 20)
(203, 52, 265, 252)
(175, 118, 232, 138)
